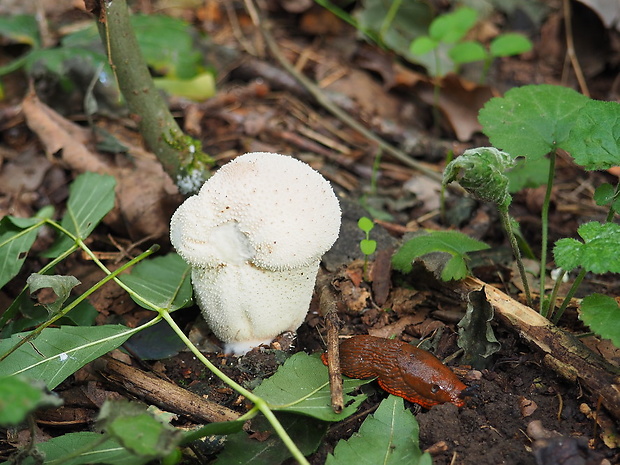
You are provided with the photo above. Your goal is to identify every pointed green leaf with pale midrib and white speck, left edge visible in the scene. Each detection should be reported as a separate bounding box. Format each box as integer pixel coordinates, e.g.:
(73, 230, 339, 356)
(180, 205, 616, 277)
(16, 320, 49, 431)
(0, 325, 138, 389)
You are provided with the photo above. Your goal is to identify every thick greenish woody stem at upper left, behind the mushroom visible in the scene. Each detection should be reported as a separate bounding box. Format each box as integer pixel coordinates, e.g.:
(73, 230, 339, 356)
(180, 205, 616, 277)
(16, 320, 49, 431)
(98, 0, 183, 181)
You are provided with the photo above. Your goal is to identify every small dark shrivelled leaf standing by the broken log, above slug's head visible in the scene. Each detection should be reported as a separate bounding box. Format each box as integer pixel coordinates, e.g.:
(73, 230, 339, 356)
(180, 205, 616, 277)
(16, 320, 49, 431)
(458, 289, 501, 369)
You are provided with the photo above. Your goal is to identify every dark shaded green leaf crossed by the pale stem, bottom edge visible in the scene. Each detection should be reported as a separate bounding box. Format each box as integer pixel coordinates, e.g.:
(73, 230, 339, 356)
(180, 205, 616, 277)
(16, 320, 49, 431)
(214, 412, 329, 465)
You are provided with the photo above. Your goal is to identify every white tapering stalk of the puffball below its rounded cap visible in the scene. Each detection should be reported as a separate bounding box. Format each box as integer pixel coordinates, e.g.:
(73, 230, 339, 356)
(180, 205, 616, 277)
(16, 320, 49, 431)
(192, 260, 319, 354)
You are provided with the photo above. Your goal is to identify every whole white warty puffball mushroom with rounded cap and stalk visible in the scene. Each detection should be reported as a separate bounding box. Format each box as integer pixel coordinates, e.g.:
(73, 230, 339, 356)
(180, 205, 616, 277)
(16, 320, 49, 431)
(170, 152, 341, 354)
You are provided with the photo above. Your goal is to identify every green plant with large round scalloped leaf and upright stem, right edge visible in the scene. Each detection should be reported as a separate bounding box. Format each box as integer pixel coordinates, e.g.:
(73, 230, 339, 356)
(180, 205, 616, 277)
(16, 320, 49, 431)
(470, 85, 620, 347)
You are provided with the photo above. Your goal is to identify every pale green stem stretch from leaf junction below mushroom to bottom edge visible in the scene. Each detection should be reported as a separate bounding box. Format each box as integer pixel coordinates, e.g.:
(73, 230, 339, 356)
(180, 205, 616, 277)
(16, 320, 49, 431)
(160, 310, 309, 465)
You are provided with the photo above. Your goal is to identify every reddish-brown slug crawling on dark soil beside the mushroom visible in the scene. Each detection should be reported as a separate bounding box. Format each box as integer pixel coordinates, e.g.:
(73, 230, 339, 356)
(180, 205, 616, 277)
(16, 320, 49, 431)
(321, 336, 466, 408)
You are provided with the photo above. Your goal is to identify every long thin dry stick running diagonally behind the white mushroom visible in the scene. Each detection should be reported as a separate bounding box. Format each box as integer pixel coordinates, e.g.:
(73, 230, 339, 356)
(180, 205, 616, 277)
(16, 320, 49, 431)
(246, 1, 442, 183)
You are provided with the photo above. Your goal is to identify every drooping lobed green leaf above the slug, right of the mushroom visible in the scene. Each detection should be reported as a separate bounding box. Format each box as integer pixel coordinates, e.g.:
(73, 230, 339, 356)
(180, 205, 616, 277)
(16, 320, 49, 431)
(392, 231, 489, 281)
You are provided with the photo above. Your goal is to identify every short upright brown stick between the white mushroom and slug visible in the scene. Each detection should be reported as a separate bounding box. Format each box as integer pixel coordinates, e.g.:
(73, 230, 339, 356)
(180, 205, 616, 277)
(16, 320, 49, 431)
(319, 283, 344, 413)
